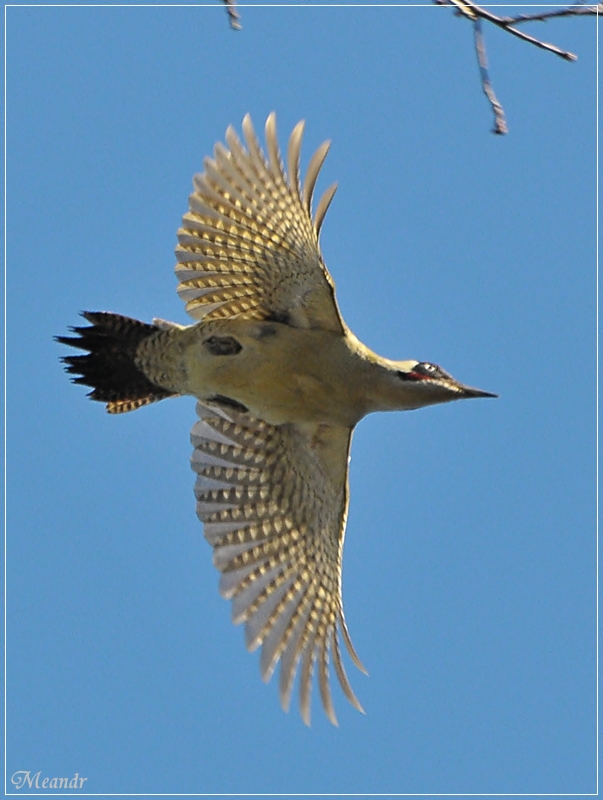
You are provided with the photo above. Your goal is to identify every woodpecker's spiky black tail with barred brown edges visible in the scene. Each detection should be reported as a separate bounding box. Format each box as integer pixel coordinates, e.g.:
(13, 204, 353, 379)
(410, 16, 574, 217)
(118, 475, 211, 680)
(55, 311, 175, 414)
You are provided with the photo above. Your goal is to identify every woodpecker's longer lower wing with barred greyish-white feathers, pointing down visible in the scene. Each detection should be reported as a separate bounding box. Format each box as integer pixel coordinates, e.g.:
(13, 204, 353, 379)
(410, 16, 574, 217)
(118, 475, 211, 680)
(191, 403, 364, 724)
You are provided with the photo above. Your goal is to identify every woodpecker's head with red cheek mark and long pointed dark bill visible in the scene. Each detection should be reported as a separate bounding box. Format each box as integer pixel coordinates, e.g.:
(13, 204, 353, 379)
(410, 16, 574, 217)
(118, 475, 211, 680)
(380, 360, 498, 410)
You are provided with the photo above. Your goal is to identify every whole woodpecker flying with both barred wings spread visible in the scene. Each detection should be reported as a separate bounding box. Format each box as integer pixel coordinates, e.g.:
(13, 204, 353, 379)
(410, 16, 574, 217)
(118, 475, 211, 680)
(57, 114, 496, 725)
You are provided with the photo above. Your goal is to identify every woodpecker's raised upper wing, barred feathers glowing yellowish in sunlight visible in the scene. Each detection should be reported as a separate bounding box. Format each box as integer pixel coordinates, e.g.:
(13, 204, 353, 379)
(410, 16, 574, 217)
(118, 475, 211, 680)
(176, 114, 343, 333)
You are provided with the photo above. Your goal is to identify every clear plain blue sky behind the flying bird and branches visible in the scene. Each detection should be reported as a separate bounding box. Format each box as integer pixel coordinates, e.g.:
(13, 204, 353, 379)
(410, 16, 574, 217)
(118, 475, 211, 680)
(7, 5, 596, 794)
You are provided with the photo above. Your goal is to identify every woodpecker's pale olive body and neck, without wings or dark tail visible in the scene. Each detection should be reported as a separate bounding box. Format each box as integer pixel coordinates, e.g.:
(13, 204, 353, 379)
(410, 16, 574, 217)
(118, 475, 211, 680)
(133, 319, 472, 428)
